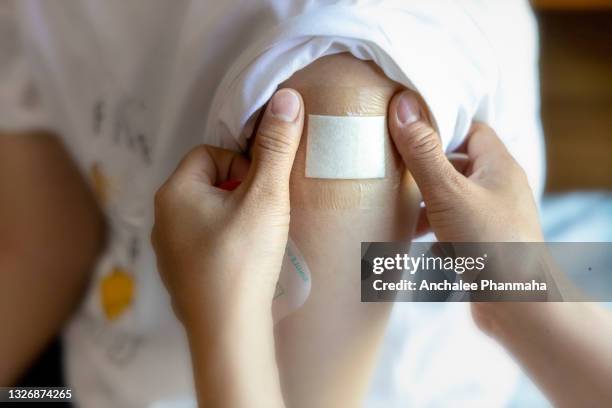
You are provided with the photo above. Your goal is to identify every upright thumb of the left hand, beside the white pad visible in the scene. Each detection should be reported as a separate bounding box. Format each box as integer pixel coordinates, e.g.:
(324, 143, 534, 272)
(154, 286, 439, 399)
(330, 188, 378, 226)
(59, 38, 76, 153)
(246, 88, 304, 194)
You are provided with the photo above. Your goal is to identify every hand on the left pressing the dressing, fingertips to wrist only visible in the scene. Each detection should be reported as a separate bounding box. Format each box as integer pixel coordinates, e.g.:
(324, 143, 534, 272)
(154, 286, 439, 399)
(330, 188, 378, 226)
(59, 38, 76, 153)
(151, 89, 304, 328)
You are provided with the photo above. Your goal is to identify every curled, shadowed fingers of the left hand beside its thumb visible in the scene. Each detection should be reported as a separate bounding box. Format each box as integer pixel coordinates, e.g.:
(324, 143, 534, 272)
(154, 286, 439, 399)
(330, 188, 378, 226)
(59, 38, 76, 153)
(170, 145, 249, 186)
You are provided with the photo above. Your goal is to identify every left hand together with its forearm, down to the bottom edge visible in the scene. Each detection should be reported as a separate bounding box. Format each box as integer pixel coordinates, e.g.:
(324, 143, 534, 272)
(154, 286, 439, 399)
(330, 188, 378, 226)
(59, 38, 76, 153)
(151, 90, 304, 407)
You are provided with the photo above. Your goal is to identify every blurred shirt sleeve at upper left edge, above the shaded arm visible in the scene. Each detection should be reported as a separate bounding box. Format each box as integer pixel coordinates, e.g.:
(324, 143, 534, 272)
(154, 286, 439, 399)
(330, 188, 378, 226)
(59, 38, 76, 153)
(0, 0, 50, 131)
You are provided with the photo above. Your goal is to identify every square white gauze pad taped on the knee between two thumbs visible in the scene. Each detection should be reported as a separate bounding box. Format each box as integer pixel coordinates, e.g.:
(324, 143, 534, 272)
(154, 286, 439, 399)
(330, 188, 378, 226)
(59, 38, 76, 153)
(306, 115, 387, 179)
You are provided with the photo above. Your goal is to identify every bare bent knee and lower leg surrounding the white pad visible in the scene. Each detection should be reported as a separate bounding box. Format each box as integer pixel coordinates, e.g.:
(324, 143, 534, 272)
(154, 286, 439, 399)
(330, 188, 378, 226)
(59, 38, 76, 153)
(275, 54, 419, 407)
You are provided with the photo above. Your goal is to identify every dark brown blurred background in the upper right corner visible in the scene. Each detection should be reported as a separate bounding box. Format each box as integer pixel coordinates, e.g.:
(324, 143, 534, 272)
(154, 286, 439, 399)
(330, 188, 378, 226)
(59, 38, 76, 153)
(533, 0, 612, 193)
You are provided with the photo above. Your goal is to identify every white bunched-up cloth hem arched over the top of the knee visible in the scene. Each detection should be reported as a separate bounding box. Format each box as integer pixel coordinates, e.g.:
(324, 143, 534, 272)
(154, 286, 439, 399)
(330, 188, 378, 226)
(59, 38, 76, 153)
(204, 0, 498, 148)
